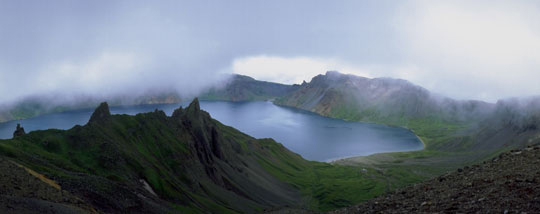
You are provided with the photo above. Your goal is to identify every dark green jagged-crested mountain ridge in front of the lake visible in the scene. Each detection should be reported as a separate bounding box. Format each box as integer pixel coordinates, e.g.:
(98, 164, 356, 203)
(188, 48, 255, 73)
(0, 99, 399, 213)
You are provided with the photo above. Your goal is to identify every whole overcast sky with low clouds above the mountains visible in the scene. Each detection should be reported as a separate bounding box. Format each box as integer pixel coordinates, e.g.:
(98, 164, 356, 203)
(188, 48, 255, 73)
(0, 0, 540, 103)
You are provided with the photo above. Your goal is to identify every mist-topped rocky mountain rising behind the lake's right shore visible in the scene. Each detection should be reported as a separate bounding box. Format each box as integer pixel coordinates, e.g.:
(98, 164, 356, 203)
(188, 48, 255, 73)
(275, 71, 493, 126)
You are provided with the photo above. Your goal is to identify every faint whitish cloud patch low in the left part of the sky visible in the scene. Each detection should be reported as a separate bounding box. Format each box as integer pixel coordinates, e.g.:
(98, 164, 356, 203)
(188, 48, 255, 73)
(16, 52, 148, 102)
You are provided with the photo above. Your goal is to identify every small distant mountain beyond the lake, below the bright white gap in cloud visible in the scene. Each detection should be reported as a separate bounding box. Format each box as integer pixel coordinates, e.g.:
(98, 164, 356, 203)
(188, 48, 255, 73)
(199, 74, 298, 101)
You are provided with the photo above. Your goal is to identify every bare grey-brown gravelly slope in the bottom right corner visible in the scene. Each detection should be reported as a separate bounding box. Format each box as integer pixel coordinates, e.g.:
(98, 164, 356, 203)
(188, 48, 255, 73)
(331, 145, 540, 213)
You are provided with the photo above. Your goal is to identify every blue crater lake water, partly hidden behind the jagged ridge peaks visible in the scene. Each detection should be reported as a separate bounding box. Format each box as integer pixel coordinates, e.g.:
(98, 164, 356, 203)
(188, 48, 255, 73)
(0, 101, 424, 161)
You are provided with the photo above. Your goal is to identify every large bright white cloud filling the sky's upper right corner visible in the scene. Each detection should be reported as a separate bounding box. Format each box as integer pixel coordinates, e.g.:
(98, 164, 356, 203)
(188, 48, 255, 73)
(394, 1, 540, 101)
